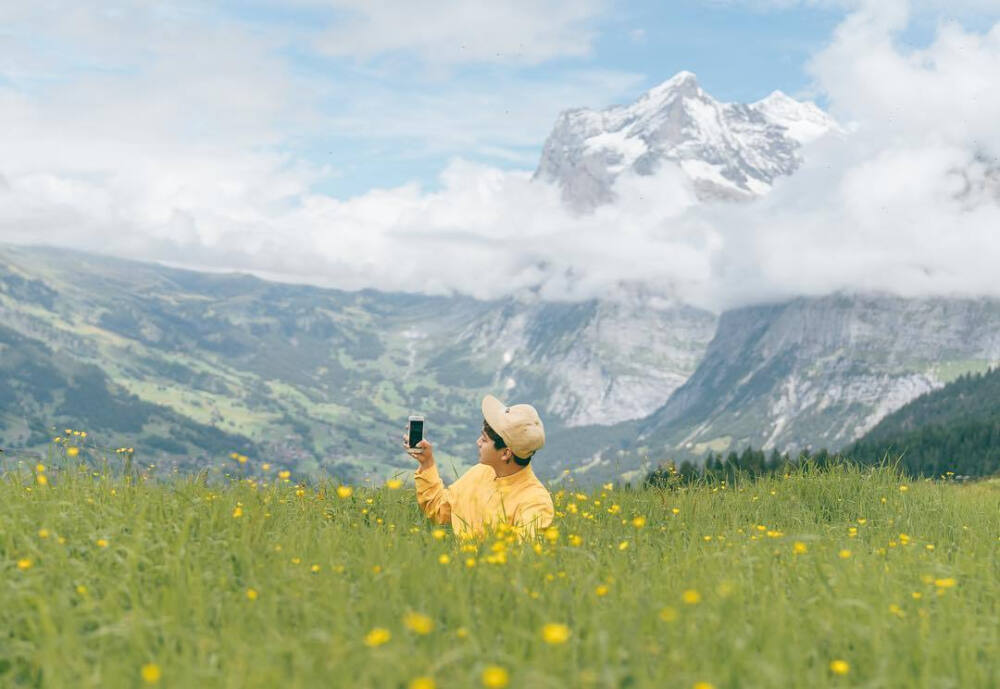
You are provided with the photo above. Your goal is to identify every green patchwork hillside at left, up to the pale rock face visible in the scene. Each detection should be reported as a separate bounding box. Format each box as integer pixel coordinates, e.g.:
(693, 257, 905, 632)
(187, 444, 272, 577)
(0, 247, 500, 480)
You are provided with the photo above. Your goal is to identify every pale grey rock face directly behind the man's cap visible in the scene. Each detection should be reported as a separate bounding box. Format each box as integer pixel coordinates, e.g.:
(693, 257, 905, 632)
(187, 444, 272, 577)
(454, 295, 716, 427)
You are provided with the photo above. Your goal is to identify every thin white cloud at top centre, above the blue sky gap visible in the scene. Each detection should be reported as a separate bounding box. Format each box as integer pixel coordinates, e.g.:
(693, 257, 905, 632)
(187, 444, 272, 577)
(308, 0, 606, 65)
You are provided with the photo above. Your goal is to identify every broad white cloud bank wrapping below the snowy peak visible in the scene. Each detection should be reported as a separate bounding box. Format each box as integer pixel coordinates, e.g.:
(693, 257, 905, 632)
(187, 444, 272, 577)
(0, 2, 1000, 309)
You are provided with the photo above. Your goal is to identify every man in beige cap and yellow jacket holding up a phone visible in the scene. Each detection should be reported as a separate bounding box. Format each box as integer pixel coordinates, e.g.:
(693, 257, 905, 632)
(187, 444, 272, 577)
(406, 395, 554, 536)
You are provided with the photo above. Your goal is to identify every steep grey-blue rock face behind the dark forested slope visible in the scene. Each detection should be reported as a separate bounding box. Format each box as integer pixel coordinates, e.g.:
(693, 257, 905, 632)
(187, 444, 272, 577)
(638, 295, 1000, 456)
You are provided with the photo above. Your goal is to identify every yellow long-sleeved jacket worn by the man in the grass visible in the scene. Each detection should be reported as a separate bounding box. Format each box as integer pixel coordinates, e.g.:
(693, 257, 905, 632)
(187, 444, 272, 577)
(414, 464, 555, 536)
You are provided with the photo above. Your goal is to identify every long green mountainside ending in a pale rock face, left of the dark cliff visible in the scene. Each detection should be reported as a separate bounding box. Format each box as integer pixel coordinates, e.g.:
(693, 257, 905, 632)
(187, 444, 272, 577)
(0, 247, 716, 478)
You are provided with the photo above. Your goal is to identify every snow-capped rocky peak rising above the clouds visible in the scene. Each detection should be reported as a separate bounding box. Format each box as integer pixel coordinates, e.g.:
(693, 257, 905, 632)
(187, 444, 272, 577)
(535, 72, 840, 211)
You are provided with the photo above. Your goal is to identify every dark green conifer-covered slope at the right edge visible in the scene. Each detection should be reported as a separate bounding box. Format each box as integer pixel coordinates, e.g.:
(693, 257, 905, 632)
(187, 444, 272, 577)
(845, 368, 1000, 477)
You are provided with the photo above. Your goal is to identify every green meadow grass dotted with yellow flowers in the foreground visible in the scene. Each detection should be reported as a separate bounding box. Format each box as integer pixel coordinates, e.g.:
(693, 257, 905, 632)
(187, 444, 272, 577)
(0, 448, 1000, 689)
